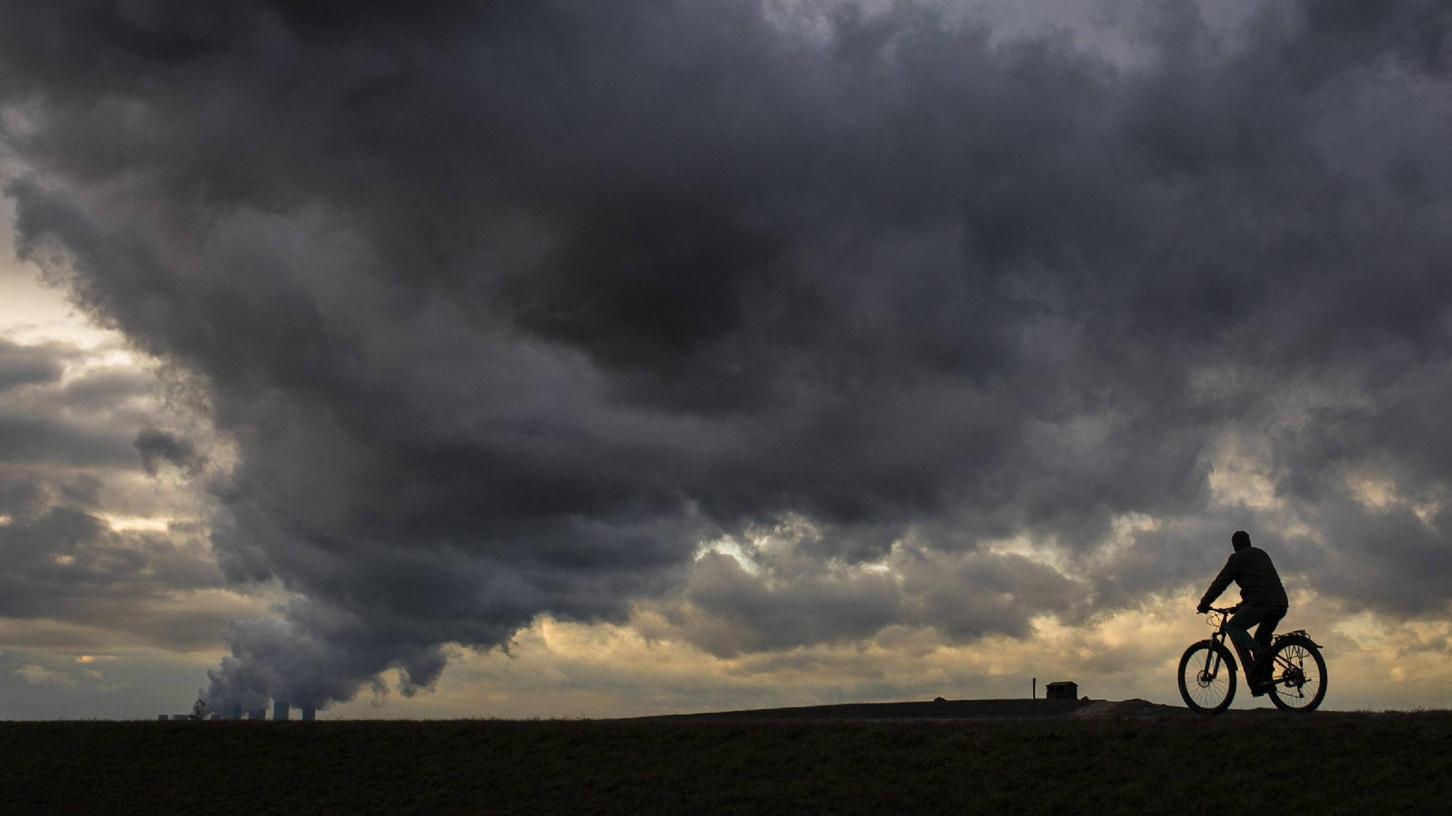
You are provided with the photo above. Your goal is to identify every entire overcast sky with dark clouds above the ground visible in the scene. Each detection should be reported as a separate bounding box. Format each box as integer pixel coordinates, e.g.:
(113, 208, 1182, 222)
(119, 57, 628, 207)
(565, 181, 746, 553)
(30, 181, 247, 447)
(0, 0, 1452, 717)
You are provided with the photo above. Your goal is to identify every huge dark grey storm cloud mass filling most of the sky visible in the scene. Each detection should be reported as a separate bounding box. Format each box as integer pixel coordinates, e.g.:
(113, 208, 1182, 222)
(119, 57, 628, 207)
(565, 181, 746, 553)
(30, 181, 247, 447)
(0, 0, 1452, 700)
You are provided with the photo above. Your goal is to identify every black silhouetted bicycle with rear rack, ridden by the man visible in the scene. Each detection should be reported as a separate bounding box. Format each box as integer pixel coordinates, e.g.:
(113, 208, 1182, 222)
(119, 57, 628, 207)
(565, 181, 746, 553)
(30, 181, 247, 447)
(1179, 607, 1326, 714)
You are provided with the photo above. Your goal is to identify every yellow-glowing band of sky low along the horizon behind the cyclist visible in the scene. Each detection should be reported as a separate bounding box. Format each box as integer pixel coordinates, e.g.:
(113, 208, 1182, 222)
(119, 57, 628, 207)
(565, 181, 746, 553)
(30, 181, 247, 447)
(360, 577, 1452, 717)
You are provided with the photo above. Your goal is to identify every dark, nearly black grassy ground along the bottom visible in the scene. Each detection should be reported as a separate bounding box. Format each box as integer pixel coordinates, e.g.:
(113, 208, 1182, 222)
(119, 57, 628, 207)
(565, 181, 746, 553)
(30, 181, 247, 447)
(0, 711, 1452, 815)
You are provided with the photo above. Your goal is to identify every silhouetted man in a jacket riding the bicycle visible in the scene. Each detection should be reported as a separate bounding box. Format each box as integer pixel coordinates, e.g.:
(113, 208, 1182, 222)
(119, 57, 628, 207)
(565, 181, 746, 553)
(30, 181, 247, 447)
(1195, 530, 1291, 697)
